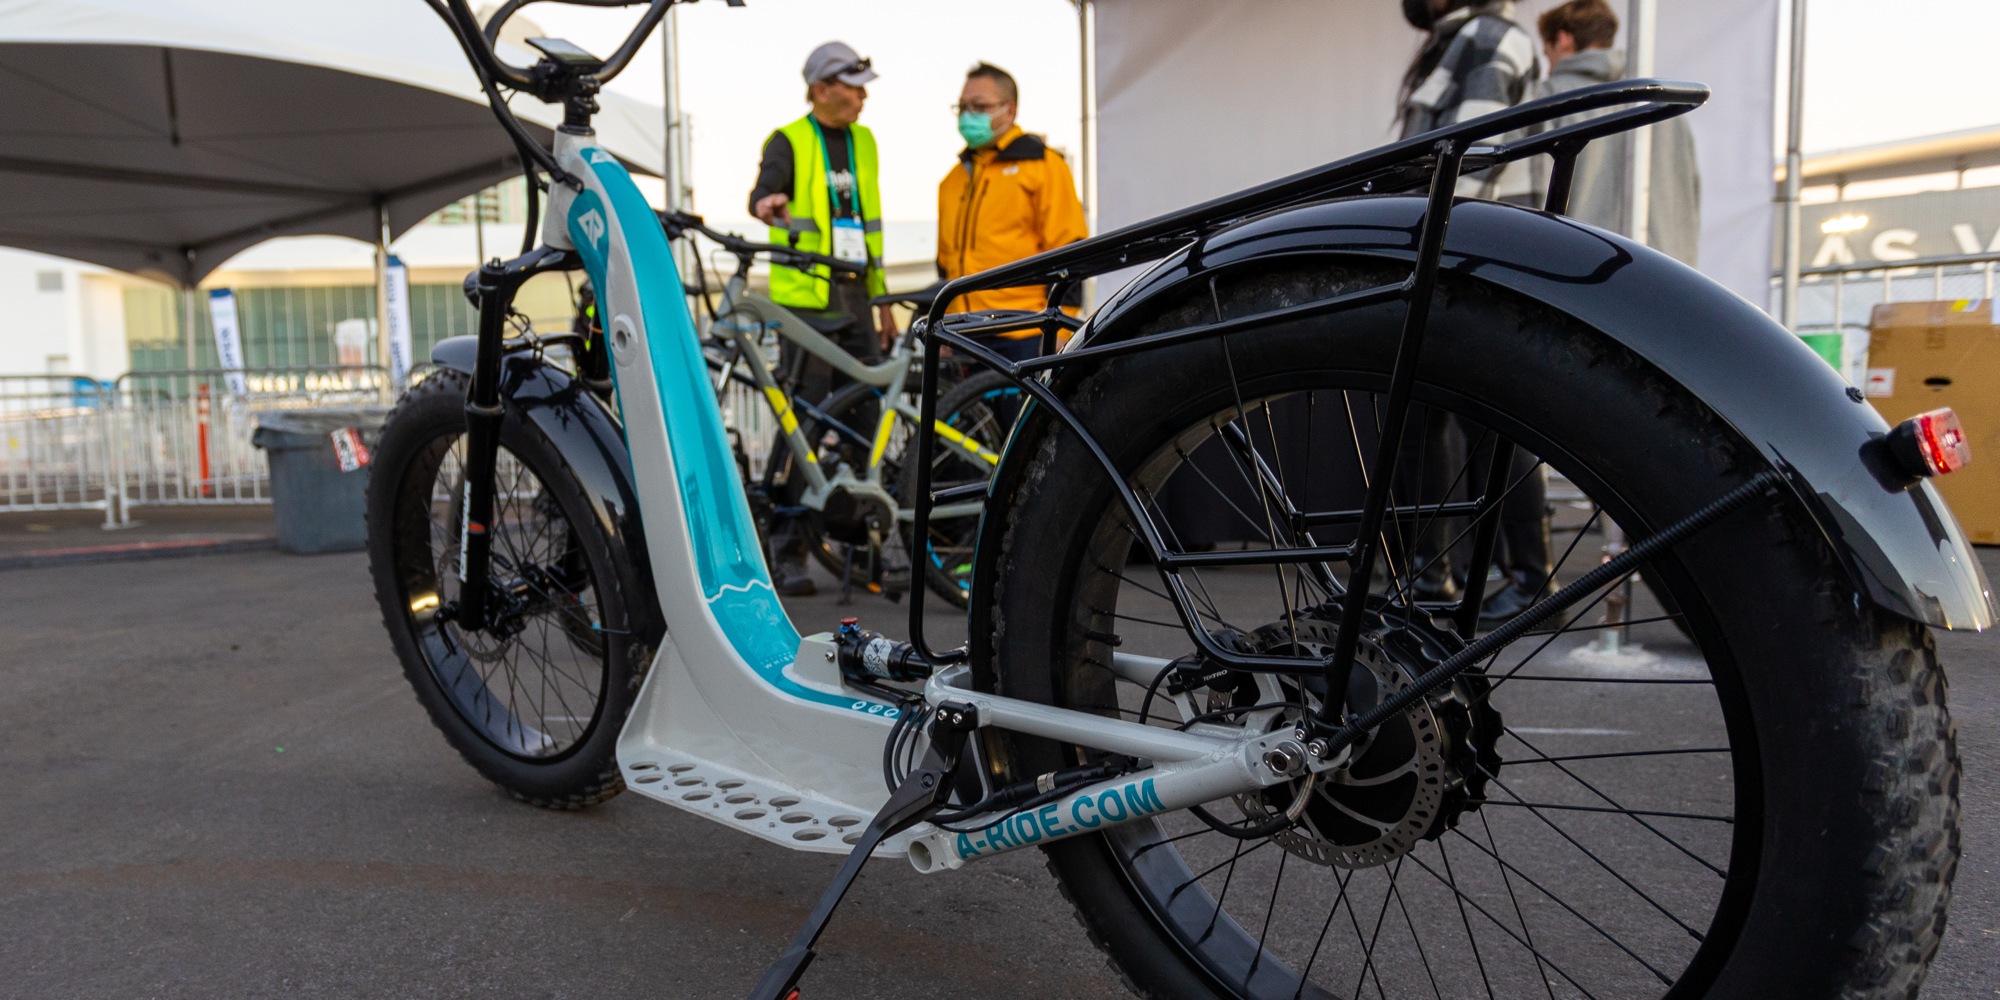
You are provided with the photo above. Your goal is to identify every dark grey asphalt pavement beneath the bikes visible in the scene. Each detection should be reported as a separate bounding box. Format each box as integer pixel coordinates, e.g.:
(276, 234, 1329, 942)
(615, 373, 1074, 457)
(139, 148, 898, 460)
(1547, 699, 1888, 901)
(0, 550, 2000, 1000)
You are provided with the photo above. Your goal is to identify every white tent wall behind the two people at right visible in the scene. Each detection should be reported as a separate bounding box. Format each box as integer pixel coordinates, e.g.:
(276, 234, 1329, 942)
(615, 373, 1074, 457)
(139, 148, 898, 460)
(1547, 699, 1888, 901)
(1094, 0, 1780, 306)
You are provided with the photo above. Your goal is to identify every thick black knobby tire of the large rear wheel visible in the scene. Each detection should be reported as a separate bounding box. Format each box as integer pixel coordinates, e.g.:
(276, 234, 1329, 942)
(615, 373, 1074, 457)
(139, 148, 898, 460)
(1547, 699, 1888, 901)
(970, 272, 1960, 1000)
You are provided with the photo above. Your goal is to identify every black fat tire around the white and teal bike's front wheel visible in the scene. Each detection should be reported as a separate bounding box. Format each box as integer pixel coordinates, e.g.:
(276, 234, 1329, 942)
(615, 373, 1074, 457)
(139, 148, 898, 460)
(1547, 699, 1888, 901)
(368, 370, 650, 810)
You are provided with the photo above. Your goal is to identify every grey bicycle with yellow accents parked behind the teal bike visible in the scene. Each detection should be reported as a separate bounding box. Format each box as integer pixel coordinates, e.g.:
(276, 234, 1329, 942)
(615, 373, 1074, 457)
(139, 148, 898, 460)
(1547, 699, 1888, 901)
(662, 212, 1010, 606)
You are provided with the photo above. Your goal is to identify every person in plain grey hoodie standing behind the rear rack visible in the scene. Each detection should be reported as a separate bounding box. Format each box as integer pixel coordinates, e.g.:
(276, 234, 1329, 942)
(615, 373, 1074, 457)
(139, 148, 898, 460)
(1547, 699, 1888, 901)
(1530, 0, 1702, 264)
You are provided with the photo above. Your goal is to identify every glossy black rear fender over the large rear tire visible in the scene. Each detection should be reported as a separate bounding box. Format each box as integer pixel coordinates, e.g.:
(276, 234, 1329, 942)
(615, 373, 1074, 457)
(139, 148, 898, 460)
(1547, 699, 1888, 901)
(978, 196, 1996, 628)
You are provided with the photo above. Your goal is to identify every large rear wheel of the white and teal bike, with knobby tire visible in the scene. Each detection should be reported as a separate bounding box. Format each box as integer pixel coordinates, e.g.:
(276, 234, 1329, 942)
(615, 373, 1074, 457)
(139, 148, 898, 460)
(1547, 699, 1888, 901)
(970, 266, 1958, 1000)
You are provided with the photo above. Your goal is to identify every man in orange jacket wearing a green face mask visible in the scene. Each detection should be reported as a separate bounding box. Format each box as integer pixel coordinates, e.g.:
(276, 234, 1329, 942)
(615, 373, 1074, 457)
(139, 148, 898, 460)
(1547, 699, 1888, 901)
(938, 62, 1088, 354)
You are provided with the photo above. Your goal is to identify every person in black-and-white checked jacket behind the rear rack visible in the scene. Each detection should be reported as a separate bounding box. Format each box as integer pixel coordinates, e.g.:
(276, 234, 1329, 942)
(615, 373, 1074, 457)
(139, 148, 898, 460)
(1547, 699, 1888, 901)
(1398, 0, 1542, 200)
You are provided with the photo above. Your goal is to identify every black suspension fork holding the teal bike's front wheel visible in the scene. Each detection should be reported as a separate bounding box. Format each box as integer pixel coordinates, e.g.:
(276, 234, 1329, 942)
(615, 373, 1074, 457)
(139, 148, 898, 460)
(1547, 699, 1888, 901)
(456, 246, 580, 630)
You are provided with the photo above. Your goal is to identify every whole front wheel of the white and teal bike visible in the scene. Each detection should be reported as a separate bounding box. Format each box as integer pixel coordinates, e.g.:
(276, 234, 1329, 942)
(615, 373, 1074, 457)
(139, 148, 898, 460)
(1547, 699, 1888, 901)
(368, 370, 650, 808)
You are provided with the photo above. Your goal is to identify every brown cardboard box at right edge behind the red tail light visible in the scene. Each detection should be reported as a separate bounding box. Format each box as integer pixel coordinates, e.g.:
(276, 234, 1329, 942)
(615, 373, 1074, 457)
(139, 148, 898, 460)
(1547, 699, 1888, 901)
(1866, 300, 2000, 546)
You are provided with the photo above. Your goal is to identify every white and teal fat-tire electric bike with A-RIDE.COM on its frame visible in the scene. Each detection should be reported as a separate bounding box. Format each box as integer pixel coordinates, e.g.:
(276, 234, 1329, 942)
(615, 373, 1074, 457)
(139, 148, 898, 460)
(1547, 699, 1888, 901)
(370, 0, 1994, 1000)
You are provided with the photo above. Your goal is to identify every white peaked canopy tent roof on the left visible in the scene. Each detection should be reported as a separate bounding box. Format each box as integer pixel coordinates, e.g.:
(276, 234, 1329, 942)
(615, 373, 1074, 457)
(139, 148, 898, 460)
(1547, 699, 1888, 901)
(0, 0, 664, 286)
